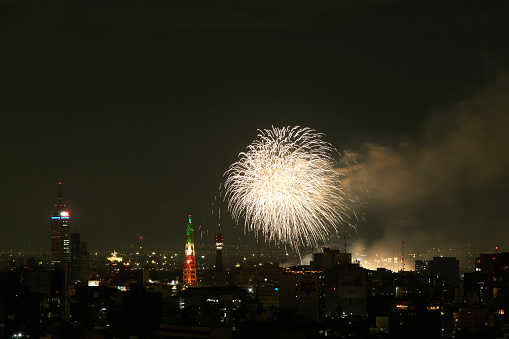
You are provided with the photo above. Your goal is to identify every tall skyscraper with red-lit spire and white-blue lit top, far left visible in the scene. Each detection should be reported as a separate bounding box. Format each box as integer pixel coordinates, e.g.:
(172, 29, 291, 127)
(51, 182, 71, 264)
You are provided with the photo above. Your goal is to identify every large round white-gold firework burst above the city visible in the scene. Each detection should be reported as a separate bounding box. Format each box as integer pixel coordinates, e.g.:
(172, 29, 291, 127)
(225, 126, 353, 251)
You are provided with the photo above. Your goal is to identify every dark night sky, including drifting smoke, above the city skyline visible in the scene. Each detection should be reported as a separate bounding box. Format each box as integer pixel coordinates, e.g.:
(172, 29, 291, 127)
(0, 0, 509, 250)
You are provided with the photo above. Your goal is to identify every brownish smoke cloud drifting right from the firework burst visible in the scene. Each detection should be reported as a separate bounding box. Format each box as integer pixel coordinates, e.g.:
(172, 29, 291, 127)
(355, 77, 509, 250)
